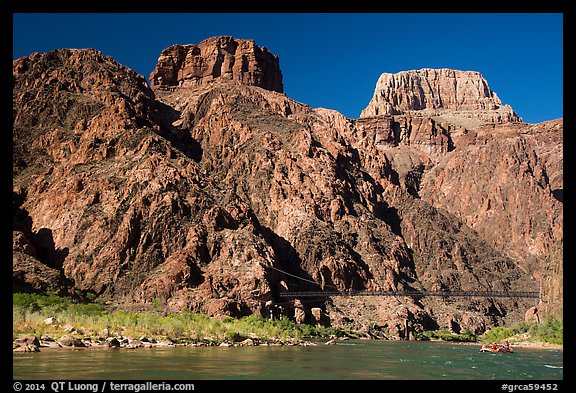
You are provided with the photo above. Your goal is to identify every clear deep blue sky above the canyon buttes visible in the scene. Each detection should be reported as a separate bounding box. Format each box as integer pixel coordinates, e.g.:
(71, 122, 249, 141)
(13, 13, 563, 123)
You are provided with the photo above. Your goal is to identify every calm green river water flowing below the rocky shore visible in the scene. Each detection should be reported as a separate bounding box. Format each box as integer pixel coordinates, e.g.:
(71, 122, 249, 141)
(12, 340, 563, 381)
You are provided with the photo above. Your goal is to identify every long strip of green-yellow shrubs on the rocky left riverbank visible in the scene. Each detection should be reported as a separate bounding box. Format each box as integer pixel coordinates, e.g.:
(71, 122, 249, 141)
(12, 293, 354, 346)
